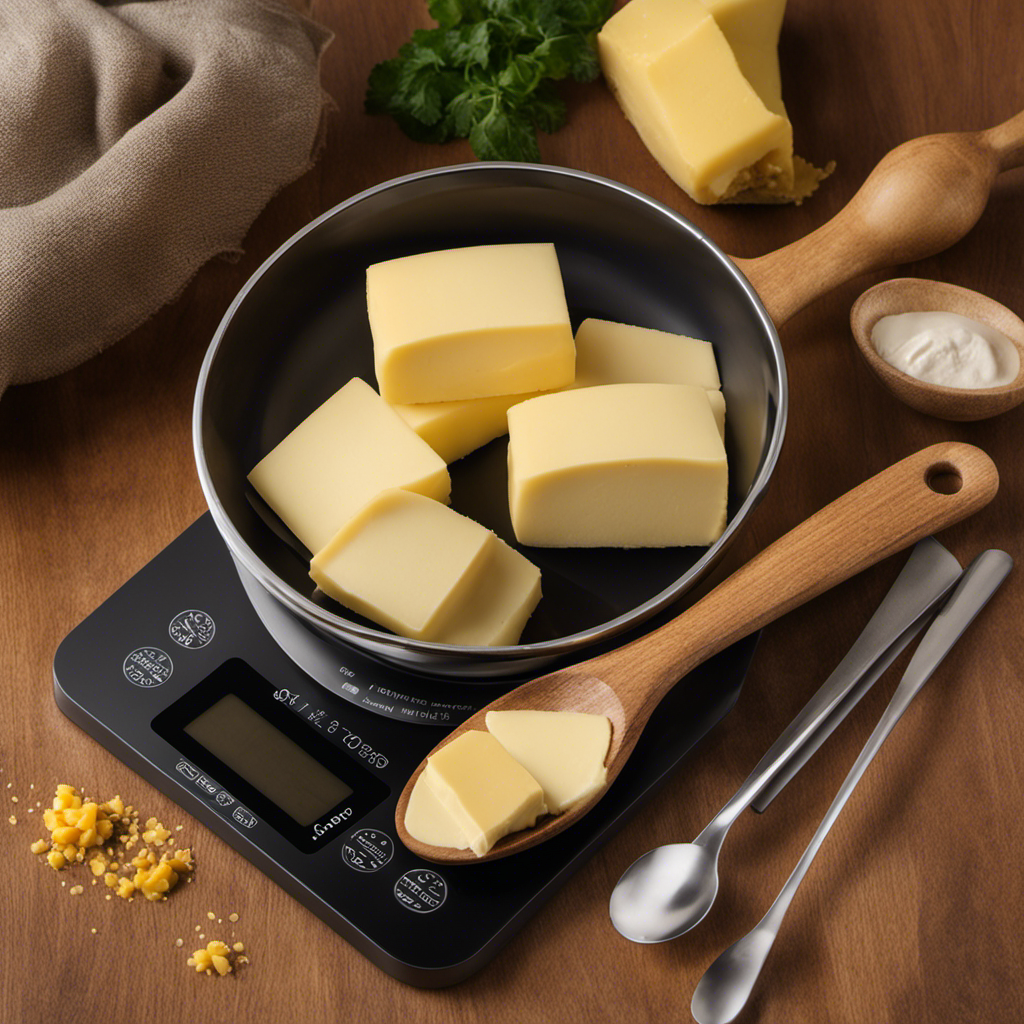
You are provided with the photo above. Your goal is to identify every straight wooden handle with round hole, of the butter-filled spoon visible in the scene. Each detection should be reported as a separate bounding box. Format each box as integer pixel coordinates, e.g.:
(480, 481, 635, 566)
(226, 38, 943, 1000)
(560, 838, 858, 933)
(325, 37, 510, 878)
(578, 441, 999, 729)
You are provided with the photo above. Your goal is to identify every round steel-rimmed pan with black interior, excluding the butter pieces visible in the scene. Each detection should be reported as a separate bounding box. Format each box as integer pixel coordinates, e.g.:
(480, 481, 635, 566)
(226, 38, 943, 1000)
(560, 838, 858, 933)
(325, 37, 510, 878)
(194, 164, 787, 682)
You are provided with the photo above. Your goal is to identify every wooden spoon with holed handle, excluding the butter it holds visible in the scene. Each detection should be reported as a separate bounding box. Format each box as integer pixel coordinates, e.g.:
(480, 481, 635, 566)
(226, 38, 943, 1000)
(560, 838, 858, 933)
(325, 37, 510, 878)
(395, 441, 998, 864)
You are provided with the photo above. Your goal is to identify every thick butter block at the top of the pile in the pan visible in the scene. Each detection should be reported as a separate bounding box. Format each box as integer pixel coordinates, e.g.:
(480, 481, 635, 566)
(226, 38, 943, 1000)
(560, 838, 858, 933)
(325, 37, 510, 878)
(367, 243, 575, 403)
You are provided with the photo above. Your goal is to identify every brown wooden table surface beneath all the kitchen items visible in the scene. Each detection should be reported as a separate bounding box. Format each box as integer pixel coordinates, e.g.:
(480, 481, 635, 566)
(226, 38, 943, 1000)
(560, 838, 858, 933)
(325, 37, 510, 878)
(0, 0, 1024, 1024)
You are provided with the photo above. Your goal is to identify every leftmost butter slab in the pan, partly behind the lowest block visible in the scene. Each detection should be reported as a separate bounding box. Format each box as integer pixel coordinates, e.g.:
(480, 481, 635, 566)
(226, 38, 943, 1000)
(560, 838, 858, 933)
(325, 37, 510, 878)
(249, 377, 452, 552)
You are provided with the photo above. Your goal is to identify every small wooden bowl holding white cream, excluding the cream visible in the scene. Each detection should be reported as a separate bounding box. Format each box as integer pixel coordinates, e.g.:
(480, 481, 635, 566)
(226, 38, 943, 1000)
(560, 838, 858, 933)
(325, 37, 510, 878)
(850, 278, 1024, 420)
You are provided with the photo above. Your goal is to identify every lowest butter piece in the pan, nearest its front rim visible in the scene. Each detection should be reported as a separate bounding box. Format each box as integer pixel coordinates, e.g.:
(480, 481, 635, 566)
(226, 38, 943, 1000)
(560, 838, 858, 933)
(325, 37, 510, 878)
(309, 488, 541, 646)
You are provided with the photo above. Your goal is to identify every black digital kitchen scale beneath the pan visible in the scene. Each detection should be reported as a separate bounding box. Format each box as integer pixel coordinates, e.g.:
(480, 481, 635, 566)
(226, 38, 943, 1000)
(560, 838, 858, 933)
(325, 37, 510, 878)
(53, 513, 757, 987)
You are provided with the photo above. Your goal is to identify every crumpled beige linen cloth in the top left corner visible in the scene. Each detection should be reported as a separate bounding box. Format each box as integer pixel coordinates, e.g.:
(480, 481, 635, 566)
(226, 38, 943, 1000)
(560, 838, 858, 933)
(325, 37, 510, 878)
(0, 0, 331, 393)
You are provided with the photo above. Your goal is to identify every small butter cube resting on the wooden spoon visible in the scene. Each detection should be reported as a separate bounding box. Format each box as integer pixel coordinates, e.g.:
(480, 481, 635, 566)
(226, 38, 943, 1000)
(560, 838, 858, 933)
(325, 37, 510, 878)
(419, 729, 547, 857)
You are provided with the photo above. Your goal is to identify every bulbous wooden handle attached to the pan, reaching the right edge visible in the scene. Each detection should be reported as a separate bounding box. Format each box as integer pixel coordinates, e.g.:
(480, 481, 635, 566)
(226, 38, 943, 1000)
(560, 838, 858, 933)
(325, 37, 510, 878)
(734, 112, 1024, 327)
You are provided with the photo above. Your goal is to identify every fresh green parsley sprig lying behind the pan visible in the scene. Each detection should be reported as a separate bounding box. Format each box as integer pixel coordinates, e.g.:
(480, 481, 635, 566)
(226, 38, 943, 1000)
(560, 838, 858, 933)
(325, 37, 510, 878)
(366, 0, 613, 162)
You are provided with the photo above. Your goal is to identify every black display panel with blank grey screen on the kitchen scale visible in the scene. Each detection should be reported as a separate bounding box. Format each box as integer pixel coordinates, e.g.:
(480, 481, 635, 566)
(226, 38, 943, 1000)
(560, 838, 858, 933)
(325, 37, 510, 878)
(153, 658, 390, 852)
